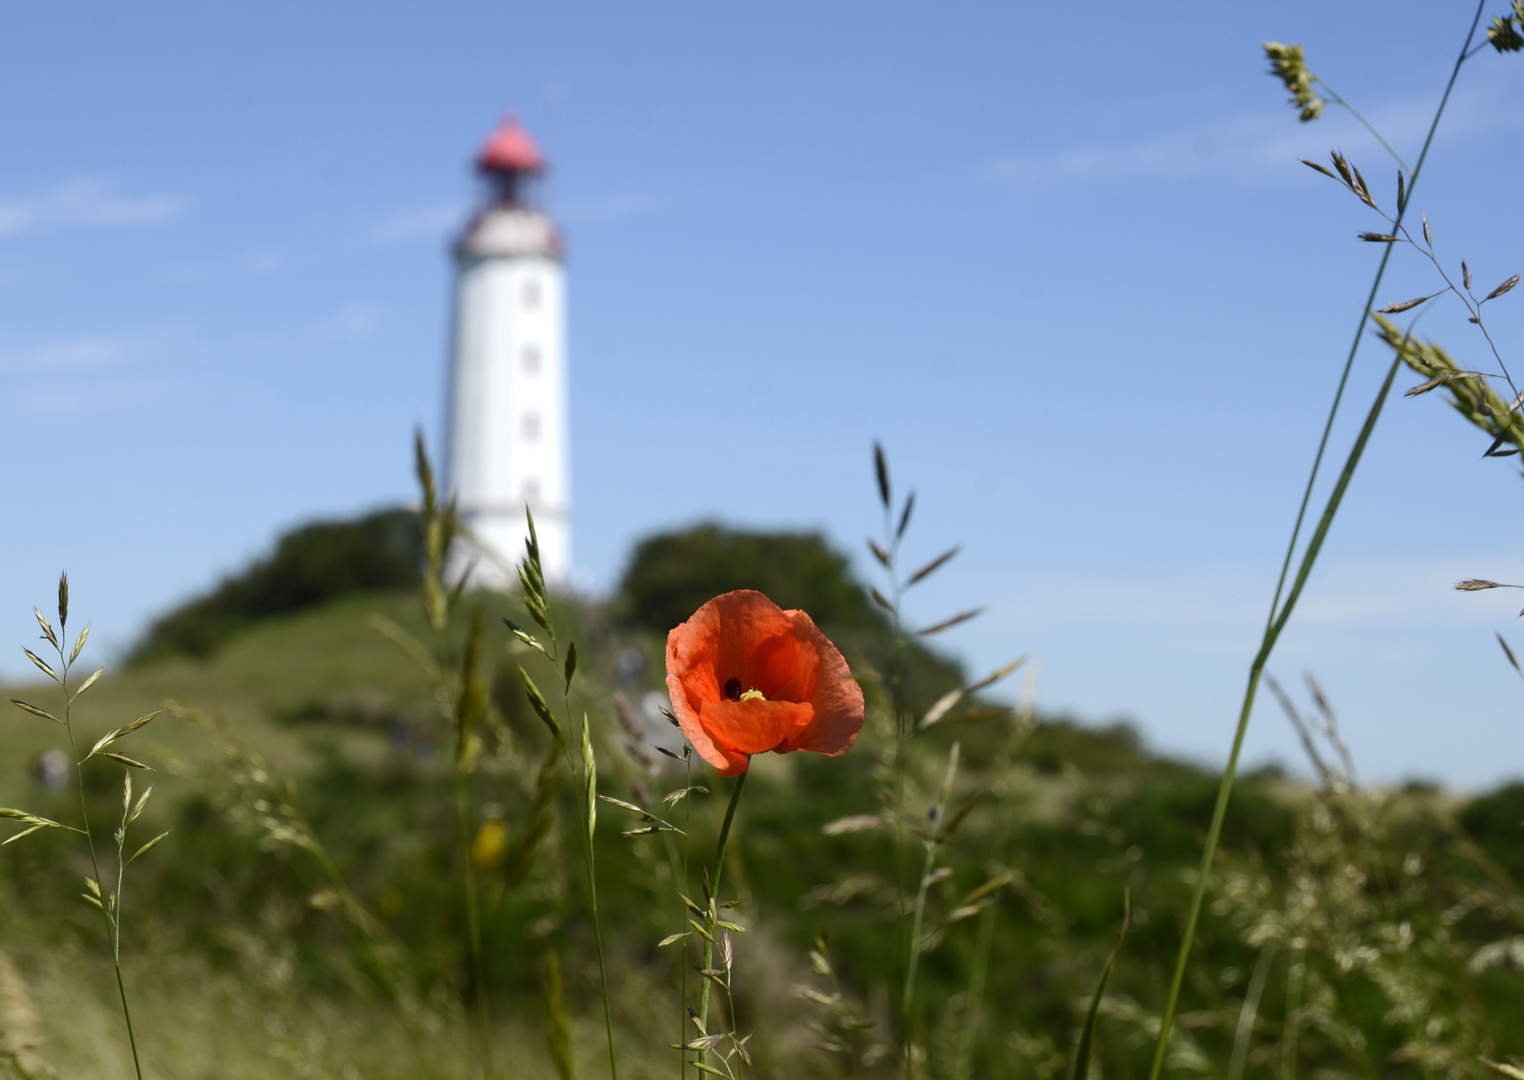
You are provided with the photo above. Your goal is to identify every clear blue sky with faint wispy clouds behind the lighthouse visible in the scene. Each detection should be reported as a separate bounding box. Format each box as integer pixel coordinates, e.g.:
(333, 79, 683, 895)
(0, 3, 1524, 786)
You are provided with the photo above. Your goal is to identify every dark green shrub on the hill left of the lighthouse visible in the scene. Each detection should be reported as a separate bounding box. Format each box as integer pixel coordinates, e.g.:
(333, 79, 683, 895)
(131, 509, 424, 664)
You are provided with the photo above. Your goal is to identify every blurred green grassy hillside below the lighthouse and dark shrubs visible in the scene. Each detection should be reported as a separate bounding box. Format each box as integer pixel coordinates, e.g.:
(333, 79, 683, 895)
(0, 581, 1524, 1077)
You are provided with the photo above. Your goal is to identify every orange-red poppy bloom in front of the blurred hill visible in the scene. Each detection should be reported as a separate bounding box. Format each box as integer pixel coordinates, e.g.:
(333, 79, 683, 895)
(668, 590, 863, 777)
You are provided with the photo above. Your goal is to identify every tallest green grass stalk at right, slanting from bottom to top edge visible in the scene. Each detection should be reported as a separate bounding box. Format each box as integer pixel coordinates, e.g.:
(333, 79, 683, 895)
(1149, 0, 1486, 1080)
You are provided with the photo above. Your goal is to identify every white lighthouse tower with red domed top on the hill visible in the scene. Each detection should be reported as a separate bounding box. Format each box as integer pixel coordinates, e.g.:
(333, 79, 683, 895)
(447, 117, 572, 588)
